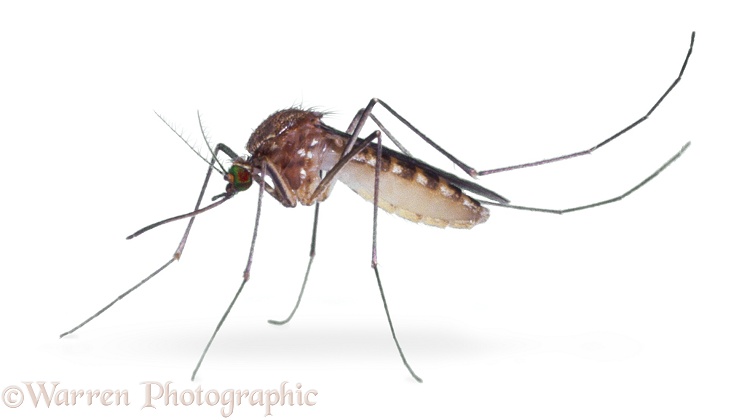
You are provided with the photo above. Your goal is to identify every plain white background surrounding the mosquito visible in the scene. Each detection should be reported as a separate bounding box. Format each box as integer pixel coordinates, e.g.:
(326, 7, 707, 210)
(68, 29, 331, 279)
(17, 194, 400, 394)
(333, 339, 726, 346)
(0, 1, 731, 419)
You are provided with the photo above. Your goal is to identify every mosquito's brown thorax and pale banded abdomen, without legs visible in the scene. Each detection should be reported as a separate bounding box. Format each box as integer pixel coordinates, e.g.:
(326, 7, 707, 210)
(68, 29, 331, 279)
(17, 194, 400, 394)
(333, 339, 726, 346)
(239, 109, 507, 228)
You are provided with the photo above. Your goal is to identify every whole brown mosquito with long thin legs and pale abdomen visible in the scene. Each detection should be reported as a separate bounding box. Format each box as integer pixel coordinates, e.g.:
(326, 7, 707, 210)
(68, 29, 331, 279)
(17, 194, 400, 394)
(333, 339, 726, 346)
(61, 32, 695, 382)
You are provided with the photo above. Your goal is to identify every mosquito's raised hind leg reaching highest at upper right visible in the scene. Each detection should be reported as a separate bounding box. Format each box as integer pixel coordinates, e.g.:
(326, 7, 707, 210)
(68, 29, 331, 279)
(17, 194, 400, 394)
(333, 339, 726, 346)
(346, 32, 695, 177)
